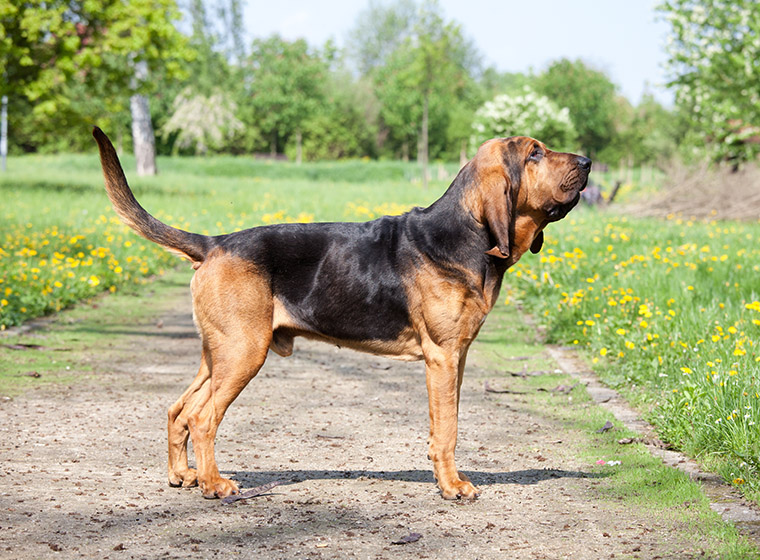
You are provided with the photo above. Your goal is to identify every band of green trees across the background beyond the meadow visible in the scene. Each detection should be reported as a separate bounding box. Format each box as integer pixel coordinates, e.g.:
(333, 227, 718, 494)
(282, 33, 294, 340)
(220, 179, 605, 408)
(0, 0, 758, 165)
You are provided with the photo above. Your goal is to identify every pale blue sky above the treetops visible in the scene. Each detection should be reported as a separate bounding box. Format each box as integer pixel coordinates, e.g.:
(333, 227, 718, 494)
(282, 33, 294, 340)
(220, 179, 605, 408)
(244, 0, 673, 105)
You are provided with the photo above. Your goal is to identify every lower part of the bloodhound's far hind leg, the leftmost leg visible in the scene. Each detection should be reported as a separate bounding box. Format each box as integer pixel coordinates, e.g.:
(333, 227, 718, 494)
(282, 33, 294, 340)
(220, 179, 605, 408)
(168, 350, 211, 486)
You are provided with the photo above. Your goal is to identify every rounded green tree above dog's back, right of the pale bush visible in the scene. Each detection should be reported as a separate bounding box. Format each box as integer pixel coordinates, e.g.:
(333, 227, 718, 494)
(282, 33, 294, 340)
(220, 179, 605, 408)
(246, 35, 327, 163)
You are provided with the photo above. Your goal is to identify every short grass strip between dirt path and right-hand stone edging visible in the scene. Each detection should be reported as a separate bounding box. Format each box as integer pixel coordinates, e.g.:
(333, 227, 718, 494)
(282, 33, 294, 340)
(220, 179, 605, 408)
(473, 300, 758, 559)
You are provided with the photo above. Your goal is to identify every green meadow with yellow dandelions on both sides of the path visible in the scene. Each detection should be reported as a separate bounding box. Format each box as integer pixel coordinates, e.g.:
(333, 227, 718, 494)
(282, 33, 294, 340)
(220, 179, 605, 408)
(0, 154, 760, 499)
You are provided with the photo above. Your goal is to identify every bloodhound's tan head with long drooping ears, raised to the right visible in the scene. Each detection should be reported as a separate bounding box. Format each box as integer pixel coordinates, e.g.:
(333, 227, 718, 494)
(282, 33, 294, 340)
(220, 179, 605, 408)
(471, 136, 591, 264)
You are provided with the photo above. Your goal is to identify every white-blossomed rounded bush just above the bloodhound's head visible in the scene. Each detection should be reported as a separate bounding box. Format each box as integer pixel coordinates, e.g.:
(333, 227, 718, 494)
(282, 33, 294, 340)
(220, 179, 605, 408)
(470, 86, 578, 150)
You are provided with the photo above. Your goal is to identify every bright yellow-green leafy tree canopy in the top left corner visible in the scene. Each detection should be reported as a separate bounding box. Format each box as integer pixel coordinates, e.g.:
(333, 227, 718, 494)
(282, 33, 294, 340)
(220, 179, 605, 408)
(0, 0, 190, 171)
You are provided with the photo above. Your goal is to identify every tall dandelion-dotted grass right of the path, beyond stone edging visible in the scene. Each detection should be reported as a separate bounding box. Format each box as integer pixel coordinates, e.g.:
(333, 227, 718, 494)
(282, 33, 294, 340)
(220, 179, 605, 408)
(506, 207, 760, 500)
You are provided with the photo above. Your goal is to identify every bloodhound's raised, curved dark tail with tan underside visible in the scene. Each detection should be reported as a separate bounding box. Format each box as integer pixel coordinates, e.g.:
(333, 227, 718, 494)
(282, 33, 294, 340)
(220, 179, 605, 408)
(92, 127, 213, 263)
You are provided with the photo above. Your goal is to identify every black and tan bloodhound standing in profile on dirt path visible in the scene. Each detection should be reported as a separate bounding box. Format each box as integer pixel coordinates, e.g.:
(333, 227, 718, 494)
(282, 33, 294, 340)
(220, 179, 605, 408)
(93, 128, 591, 499)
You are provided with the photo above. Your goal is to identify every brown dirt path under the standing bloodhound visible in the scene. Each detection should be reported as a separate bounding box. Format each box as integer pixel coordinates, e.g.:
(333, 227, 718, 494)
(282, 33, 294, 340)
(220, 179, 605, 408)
(0, 282, 748, 559)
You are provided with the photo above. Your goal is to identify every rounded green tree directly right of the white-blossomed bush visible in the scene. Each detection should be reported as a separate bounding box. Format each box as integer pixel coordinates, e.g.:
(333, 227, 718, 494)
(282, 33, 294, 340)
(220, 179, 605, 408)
(533, 59, 617, 157)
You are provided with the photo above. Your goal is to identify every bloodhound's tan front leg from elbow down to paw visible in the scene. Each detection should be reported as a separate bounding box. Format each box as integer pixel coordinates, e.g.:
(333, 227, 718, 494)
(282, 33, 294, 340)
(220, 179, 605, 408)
(425, 348, 478, 500)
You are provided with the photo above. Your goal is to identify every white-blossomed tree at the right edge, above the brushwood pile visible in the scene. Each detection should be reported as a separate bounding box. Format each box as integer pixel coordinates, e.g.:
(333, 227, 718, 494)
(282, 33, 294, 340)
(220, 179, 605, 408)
(658, 0, 760, 161)
